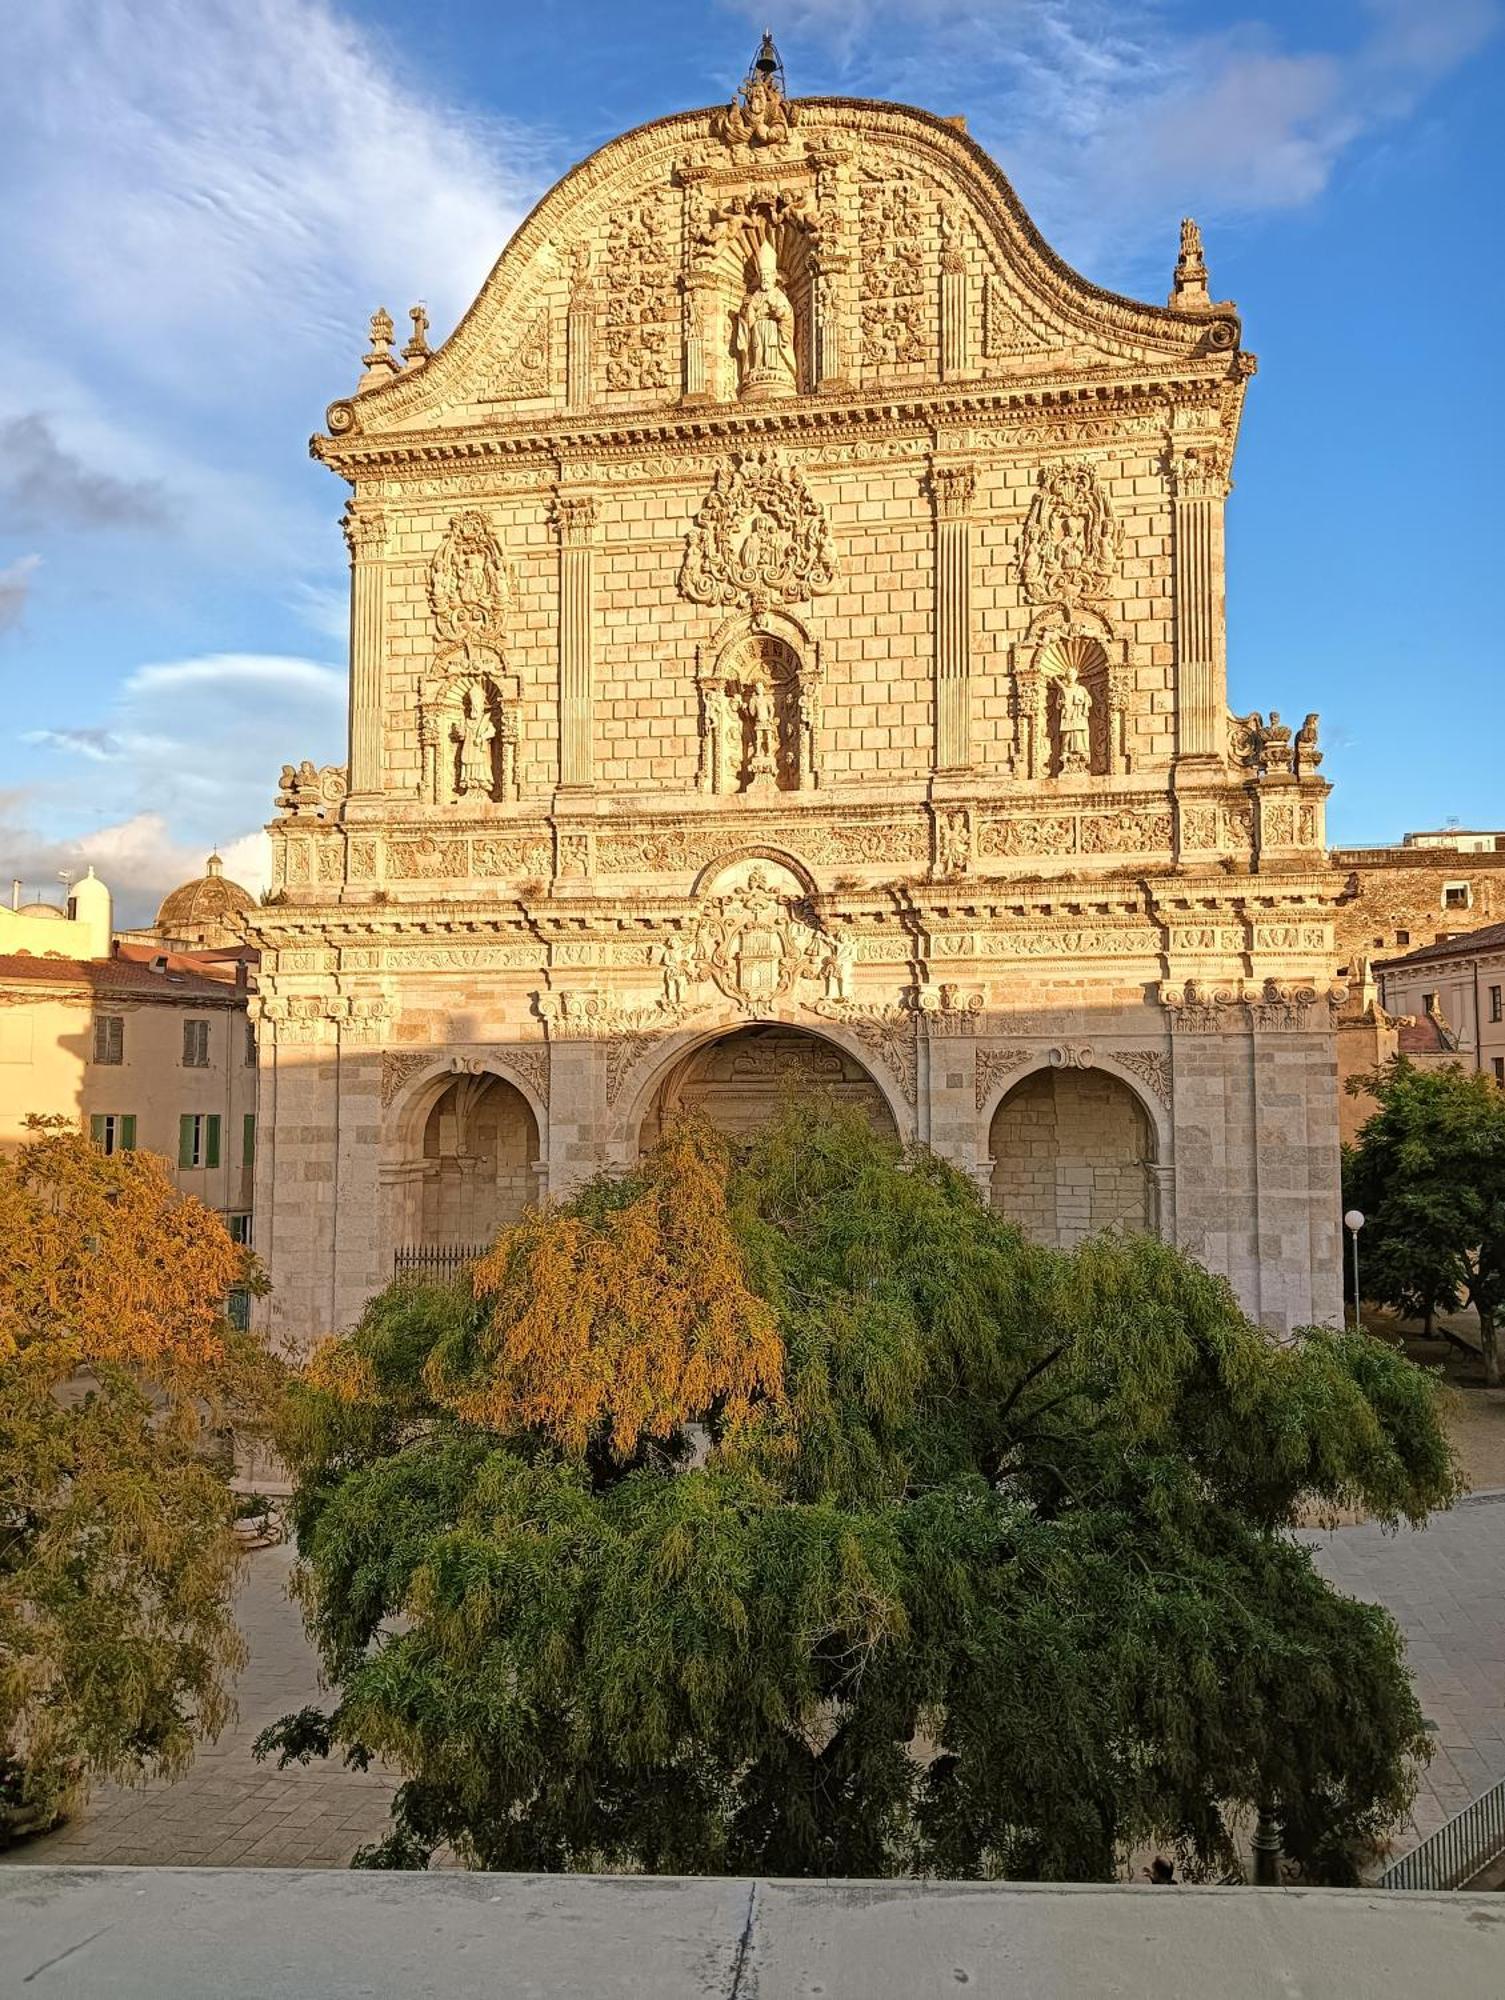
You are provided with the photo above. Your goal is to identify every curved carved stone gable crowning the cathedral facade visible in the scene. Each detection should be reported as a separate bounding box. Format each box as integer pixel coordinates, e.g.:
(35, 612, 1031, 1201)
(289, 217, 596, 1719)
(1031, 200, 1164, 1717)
(320, 98, 1239, 436)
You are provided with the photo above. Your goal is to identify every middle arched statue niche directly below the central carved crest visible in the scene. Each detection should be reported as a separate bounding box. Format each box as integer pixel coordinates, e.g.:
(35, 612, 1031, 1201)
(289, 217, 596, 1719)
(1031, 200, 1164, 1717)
(694, 612, 821, 796)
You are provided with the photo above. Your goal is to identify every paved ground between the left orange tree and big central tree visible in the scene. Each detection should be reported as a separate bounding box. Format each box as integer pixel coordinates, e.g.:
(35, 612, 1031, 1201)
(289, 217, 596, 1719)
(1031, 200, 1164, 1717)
(0, 1546, 398, 1868)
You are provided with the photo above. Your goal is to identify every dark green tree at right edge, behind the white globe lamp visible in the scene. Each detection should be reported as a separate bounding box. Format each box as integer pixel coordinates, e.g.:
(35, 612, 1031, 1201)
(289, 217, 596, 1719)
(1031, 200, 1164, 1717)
(1343, 1056, 1505, 1386)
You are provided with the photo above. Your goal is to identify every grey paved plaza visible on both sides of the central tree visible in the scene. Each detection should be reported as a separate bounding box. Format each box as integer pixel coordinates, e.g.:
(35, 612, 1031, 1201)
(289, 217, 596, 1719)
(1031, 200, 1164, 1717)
(4, 1490, 1505, 1868)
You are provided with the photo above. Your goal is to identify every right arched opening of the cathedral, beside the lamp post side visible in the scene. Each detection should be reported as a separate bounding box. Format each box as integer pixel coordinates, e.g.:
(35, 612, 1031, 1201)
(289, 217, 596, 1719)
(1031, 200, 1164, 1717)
(989, 1070, 1155, 1250)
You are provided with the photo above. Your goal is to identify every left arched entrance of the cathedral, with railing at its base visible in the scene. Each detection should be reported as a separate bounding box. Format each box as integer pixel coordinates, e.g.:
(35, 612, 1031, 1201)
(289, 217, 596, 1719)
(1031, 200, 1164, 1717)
(402, 1076, 540, 1250)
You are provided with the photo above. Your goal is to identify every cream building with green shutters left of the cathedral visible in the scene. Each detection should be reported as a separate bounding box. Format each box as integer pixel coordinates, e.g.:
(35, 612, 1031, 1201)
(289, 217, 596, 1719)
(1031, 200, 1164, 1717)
(0, 856, 256, 1242)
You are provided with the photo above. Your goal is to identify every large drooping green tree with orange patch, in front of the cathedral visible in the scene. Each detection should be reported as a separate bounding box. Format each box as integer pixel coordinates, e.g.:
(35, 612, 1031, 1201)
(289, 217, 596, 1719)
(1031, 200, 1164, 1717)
(258, 1106, 1455, 1878)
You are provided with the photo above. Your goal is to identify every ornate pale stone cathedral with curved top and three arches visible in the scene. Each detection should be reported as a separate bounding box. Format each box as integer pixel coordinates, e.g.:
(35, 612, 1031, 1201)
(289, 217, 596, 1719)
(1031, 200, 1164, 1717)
(252, 44, 1341, 1338)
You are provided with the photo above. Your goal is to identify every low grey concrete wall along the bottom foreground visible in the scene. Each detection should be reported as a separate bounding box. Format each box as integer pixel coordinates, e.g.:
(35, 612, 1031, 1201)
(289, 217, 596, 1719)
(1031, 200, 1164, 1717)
(0, 1868, 1505, 2000)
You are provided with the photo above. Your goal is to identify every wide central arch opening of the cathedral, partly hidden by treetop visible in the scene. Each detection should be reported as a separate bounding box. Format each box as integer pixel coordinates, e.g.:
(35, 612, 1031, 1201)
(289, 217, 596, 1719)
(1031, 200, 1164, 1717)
(642, 1022, 899, 1150)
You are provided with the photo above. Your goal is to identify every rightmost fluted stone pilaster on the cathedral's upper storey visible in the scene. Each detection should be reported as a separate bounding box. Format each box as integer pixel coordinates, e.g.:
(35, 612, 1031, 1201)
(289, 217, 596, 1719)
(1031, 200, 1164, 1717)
(1171, 444, 1229, 764)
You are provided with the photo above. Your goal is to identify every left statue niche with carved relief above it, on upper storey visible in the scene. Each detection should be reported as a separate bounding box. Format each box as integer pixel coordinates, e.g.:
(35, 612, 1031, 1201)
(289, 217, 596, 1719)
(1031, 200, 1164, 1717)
(418, 508, 518, 806)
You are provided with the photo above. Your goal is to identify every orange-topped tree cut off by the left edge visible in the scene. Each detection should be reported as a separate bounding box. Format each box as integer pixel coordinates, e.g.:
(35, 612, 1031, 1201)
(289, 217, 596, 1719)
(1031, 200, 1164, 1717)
(0, 1120, 274, 1822)
